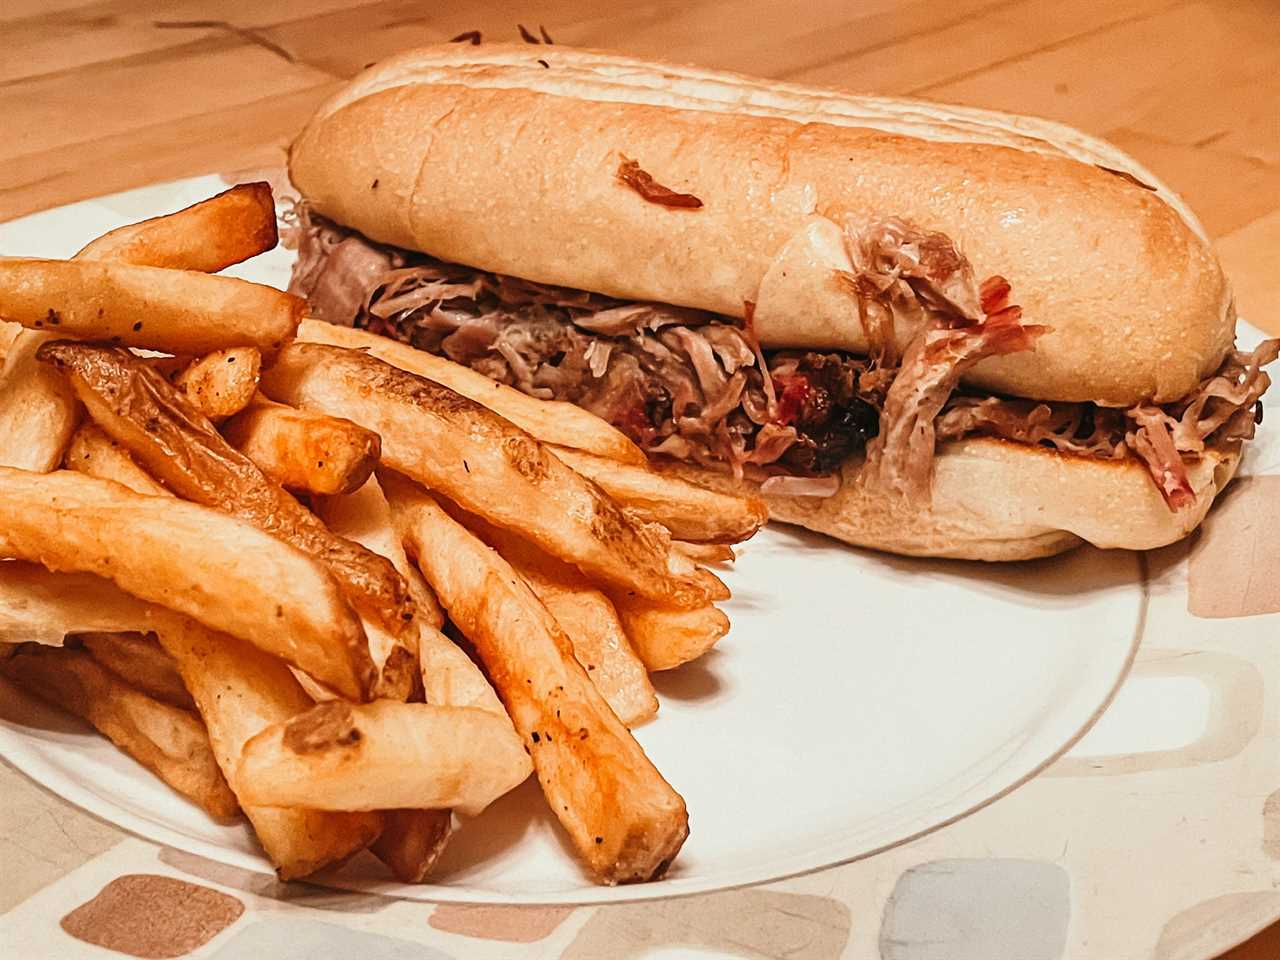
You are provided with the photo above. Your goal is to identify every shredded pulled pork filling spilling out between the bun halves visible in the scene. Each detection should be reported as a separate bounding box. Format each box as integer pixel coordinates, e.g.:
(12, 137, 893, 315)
(288, 205, 1280, 508)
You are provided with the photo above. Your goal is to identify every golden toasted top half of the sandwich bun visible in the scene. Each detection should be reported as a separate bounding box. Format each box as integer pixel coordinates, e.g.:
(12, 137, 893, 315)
(289, 44, 1235, 406)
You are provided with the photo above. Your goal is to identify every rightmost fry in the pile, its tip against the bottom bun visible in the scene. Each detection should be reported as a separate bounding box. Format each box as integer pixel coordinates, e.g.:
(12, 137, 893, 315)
(553, 447, 769, 543)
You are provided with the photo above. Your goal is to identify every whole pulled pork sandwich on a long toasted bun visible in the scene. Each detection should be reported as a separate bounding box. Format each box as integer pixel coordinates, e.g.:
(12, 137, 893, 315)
(289, 45, 1280, 559)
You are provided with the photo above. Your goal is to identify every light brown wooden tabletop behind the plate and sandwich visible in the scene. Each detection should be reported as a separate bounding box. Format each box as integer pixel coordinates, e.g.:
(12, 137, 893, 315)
(0, 0, 1280, 960)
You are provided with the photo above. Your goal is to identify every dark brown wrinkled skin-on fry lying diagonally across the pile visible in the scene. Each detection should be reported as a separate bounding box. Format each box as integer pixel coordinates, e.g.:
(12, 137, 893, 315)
(40, 340, 413, 640)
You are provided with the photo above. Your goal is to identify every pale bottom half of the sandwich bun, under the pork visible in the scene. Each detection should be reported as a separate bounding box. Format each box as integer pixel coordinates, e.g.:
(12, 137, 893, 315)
(663, 438, 1240, 561)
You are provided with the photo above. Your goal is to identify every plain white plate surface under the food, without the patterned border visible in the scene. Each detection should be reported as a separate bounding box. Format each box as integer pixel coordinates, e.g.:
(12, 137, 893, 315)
(0, 177, 1146, 904)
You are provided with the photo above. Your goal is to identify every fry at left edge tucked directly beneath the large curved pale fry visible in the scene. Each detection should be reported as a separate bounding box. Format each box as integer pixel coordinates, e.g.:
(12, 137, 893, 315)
(0, 559, 147, 646)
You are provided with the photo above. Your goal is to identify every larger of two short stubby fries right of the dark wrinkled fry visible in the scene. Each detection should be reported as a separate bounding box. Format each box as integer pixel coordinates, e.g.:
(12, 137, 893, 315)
(223, 396, 383, 495)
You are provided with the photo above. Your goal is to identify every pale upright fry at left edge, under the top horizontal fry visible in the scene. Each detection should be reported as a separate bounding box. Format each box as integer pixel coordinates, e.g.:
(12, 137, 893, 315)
(0, 330, 79, 474)
